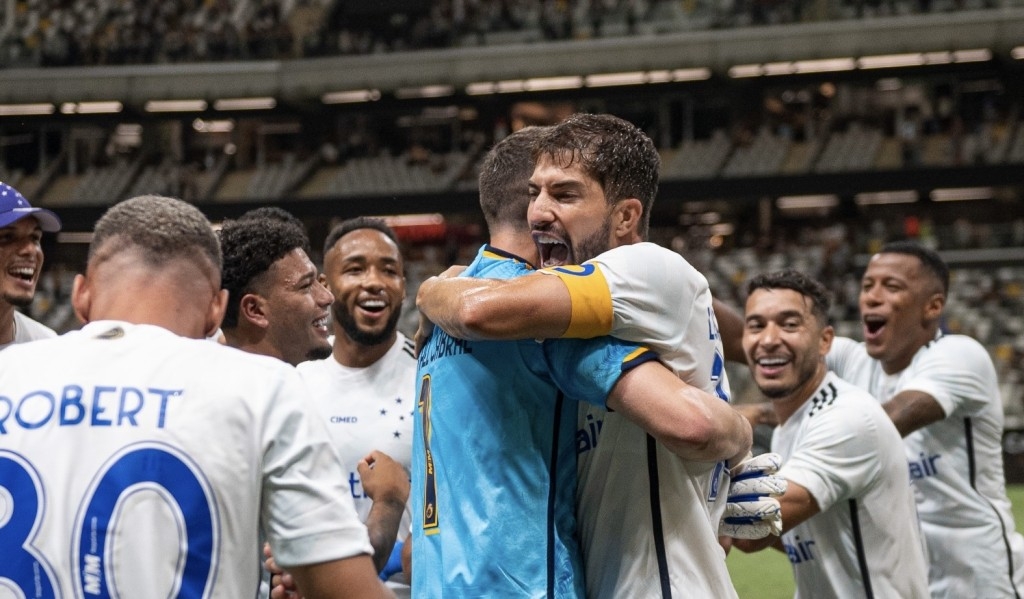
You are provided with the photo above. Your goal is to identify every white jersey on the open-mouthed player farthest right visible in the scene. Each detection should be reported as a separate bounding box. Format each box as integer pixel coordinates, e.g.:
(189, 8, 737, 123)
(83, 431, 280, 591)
(827, 334, 1024, 599)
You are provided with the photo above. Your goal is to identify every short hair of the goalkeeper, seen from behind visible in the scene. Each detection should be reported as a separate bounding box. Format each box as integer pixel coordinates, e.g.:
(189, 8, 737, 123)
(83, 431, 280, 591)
(477, 127, 550, 231)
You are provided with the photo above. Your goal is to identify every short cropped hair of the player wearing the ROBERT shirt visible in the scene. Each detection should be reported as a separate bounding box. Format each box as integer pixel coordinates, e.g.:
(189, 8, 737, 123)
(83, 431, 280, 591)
(88, 196, 222, 273)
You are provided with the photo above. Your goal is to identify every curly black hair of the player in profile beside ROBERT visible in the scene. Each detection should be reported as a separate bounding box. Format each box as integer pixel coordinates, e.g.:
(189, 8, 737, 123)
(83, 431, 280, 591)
(218, 218, 309, 329)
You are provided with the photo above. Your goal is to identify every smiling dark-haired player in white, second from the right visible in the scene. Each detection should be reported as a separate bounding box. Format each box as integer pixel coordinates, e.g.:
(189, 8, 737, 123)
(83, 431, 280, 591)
(734, 270, 929, 599)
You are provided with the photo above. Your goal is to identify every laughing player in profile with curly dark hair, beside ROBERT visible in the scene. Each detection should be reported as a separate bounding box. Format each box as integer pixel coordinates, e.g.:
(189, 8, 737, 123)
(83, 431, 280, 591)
(219, 218, 334, 366)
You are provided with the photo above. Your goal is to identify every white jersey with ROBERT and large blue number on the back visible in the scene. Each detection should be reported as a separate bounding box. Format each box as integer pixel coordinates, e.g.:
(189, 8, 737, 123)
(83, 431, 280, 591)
(0, 322, 372, 599)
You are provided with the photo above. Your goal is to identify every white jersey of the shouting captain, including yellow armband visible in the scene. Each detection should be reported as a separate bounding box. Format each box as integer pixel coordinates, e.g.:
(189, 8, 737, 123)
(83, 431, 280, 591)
(541, 243, 736, 598)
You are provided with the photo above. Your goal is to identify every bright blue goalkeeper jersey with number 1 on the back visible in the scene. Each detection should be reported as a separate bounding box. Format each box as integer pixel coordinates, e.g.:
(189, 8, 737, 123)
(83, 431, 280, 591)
(412, 246, 656, 599)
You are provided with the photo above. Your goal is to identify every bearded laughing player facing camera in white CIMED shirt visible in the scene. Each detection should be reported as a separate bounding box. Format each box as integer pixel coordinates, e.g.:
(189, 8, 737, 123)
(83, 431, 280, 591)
(299, 217, 416, 596)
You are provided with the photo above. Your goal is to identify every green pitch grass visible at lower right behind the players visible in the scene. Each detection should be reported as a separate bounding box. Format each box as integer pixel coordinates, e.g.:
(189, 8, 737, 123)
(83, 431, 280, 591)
(727, 484, 1024, 599)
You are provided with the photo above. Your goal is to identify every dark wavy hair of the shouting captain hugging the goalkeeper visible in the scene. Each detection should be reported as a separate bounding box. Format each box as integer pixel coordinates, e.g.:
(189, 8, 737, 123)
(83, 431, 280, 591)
(534, 114, 662, 238)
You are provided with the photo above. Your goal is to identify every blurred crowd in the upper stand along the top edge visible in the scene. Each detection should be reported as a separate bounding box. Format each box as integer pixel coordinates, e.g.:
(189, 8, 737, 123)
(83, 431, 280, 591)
(0, 0, 1018, 67)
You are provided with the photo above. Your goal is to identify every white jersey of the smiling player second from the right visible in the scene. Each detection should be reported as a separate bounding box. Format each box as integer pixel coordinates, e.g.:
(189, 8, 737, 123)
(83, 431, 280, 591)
(771, 373, 929, 599)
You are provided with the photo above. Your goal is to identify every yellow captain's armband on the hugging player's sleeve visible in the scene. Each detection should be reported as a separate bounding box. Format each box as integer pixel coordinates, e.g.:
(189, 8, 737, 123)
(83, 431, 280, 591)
(540, 264, 612, 339)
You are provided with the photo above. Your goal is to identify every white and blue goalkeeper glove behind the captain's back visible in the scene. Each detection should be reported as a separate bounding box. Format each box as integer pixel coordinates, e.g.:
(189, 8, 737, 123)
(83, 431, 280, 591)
(718, 454, 786, 539)
